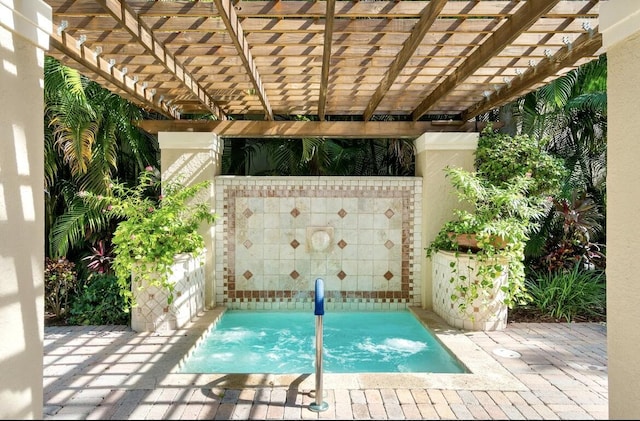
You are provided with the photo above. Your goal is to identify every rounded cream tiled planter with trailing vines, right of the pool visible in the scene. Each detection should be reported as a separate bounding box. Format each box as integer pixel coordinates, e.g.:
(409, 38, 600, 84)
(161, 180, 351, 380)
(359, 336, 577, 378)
(432, 251, 508, 331)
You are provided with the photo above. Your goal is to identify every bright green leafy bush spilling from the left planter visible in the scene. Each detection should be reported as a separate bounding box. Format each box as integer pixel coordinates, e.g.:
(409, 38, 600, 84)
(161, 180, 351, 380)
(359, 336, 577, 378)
(78, 167, 216, 305)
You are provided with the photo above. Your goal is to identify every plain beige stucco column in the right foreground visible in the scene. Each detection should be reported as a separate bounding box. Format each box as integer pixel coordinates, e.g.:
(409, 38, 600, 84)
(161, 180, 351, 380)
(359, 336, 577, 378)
(600, 0, 640, 419)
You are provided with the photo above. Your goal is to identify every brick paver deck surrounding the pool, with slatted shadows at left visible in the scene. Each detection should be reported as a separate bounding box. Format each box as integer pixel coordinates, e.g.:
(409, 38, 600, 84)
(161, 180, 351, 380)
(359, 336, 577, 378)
(43, 308, 608, 420)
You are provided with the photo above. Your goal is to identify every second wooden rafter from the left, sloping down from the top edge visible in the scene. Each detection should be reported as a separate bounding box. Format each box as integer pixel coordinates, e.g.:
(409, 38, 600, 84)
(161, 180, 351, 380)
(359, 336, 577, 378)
(95, 0, 226, 120)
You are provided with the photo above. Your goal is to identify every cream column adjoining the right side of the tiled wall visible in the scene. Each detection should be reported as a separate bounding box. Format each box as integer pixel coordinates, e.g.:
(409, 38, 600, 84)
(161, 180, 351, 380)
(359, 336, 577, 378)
(415, 133, 479, 309)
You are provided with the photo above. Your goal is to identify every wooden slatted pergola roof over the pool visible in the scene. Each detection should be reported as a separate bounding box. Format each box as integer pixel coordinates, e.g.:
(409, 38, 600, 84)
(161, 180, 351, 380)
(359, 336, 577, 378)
(46, 0, 604, 137)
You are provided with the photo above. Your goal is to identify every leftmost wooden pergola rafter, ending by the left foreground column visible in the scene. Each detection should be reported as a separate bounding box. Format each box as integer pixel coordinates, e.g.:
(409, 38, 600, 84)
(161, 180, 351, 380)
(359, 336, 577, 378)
(49, 24, 180, 119)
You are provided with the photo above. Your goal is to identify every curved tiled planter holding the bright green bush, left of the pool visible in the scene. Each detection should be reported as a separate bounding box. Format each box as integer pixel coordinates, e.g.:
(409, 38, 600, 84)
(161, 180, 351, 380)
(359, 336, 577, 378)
(131, 254, 205, 332)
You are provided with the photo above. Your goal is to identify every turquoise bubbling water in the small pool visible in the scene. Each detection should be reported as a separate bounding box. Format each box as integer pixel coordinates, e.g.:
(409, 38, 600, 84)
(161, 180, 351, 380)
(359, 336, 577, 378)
(179, 310, 467, 374)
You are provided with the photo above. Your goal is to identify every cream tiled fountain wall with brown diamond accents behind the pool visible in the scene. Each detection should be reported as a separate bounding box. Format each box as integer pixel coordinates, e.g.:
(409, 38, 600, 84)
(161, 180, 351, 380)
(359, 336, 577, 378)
(215, 176, 423, 310)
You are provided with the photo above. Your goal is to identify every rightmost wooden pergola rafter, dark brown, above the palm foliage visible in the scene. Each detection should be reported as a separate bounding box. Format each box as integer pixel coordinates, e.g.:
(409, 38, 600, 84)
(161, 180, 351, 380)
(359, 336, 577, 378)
(462, 28, 602, 120)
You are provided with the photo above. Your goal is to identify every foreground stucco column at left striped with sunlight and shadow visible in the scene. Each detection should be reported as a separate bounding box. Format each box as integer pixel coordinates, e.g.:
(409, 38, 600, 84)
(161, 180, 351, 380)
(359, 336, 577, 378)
(0, 0, 51, 419)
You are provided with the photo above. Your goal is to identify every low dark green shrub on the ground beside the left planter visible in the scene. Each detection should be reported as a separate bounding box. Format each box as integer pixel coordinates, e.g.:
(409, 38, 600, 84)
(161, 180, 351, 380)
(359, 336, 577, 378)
(67, 273, 129, 325)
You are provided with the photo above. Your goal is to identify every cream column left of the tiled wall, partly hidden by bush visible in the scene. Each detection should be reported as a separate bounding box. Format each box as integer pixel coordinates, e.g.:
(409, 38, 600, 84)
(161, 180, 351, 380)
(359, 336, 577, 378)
(158, 132, 223, 308)
